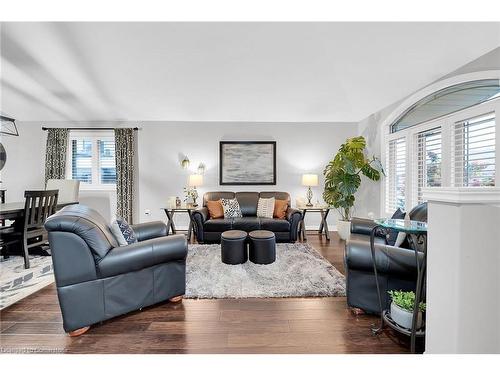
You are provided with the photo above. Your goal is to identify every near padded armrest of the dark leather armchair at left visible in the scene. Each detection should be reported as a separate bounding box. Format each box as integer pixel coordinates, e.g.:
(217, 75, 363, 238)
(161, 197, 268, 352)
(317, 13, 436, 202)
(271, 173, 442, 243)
(97, 234, 187, 278)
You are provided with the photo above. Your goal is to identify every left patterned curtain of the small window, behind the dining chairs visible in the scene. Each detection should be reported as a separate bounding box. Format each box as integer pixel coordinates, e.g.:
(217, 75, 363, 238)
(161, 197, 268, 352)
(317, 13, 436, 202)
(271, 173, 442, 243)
(45, 128, 68, 182)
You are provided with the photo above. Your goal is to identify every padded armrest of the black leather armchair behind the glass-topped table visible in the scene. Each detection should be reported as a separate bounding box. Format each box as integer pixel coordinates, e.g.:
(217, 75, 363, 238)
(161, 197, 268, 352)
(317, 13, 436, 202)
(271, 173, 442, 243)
(345, 240, 423, 280)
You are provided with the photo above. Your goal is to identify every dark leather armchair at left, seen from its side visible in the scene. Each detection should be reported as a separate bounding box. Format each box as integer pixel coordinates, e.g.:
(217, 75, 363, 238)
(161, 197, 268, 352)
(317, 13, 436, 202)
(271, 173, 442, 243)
(45, 205, 187, 332)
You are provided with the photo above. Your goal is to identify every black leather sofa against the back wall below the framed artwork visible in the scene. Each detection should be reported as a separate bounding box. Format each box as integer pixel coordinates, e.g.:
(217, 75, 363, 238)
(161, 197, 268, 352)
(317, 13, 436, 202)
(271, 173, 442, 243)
(193, 191, 302, 243)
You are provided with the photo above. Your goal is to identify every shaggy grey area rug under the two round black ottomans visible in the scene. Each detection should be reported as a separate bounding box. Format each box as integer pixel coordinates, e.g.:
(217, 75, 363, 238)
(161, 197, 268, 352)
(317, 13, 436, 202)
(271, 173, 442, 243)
(185, 243, 345, 298)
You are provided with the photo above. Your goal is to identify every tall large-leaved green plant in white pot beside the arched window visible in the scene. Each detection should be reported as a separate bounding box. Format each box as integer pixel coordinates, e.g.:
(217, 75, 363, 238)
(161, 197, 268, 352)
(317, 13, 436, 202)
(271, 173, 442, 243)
(323, 136, 384, 240)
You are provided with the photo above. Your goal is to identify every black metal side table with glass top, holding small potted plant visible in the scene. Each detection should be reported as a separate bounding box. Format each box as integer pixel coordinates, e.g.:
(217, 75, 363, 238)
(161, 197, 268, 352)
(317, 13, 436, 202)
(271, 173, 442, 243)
(370, 219, 427, 353)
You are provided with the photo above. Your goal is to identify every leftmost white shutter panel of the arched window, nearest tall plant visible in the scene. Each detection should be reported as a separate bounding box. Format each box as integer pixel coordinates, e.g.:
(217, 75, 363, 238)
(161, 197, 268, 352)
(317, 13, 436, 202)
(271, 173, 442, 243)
(385, 138, 406, 212)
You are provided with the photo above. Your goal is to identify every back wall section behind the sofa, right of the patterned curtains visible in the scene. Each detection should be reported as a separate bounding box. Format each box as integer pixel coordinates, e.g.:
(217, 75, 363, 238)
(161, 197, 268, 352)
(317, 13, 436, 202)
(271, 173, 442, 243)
(138, 122, 357, 229)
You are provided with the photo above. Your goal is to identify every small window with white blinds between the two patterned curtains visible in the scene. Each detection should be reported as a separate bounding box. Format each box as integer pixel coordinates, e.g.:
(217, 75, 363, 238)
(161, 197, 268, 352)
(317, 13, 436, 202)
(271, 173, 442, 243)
(67, 131, 116, 189)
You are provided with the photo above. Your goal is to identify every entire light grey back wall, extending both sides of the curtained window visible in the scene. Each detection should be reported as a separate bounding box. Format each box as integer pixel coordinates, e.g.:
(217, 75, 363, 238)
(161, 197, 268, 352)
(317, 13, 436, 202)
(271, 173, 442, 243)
(2, 122, 356, 230)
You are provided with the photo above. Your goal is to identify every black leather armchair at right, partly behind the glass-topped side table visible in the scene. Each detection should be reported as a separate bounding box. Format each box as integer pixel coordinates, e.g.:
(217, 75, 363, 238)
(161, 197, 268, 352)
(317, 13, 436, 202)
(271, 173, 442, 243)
(344, 203, 427, 314)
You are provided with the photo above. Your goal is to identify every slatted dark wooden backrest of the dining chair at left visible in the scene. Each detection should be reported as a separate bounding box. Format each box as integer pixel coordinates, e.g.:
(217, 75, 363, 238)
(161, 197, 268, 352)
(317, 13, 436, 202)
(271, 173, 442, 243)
(24, 190, 59, 230)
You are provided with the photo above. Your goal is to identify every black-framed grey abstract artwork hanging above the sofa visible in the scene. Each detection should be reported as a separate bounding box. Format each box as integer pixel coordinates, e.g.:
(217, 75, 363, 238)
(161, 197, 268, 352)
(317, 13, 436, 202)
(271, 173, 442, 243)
(219, 141, 276, 185)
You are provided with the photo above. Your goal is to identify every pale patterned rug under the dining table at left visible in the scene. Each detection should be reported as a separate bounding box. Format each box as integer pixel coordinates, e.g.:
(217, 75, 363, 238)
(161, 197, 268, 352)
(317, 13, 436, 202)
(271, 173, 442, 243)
(0, 255, 54, 310)
